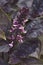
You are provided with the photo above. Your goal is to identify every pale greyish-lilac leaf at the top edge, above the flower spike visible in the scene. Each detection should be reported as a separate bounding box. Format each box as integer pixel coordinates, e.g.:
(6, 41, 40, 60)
(17, 0, 33, 8)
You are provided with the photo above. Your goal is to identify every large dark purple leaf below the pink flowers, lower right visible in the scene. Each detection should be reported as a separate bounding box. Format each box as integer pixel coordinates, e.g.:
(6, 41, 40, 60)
(8, 38, 40, 59)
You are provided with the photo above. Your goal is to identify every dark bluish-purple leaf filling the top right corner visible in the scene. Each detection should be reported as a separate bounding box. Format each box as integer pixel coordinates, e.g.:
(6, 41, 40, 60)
(31, 0, 43, 17)
